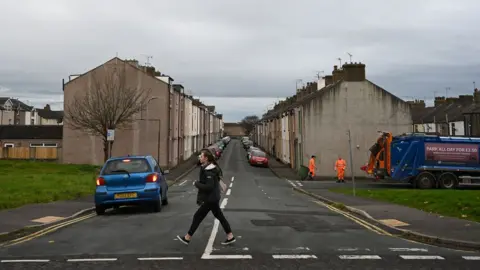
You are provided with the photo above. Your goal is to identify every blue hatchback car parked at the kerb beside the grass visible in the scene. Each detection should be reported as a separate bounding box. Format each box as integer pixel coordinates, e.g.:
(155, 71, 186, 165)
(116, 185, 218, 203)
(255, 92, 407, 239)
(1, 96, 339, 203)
(95, 156, 168, 215)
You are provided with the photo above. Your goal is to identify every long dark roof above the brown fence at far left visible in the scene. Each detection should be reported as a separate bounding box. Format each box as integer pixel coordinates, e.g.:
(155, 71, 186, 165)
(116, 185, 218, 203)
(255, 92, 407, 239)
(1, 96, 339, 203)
(0, 125, 63, 140)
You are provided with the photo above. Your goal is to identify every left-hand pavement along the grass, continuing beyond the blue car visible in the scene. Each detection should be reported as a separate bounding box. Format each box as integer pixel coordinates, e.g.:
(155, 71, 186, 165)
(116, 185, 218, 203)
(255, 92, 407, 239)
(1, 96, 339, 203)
(0, 155, 197, 238)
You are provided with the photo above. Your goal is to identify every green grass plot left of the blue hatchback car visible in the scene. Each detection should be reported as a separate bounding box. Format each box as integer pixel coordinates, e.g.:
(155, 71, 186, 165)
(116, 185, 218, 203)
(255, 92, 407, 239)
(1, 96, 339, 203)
(0, 160, 99, 210)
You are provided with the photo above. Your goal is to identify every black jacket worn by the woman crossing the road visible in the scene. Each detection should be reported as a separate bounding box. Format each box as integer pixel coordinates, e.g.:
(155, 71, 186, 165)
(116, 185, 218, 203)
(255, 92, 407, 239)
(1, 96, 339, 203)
(195, 164, 221, 204)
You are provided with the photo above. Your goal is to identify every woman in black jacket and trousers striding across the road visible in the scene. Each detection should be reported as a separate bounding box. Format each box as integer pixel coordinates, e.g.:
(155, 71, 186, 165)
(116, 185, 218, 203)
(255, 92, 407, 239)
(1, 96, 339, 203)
(177, 149, 236, 245)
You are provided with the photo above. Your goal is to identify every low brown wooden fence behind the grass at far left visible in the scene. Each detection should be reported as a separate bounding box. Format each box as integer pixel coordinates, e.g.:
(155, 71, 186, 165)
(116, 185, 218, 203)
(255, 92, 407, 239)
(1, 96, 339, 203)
(0, 147, 58, 160)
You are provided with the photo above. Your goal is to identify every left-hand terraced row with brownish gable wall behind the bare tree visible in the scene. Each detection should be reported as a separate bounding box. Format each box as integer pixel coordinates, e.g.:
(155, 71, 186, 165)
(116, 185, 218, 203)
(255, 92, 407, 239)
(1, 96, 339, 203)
(63, 57, 223, 168)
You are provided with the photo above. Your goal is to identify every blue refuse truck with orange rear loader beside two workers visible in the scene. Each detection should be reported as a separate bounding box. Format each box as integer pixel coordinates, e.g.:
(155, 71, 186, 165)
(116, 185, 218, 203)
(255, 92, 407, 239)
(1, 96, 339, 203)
(361, 131, 480, 189)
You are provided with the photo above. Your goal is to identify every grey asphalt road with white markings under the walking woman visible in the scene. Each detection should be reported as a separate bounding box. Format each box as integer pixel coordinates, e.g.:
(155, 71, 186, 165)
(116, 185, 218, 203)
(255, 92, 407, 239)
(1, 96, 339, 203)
(0, 141, 480, 270)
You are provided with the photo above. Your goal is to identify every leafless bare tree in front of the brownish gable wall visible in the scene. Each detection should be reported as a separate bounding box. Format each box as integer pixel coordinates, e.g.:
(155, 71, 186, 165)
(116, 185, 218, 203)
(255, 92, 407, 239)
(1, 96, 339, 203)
(65, 64, 151, 161)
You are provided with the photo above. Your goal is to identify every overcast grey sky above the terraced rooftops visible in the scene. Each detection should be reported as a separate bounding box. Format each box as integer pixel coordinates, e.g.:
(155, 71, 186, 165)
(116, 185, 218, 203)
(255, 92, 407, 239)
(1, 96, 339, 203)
(0, 0, 480, 121)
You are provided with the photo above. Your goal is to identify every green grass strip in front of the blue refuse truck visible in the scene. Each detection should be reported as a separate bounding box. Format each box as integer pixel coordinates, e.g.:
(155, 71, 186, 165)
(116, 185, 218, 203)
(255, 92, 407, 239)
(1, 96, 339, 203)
(331, 188, 480, 222)
